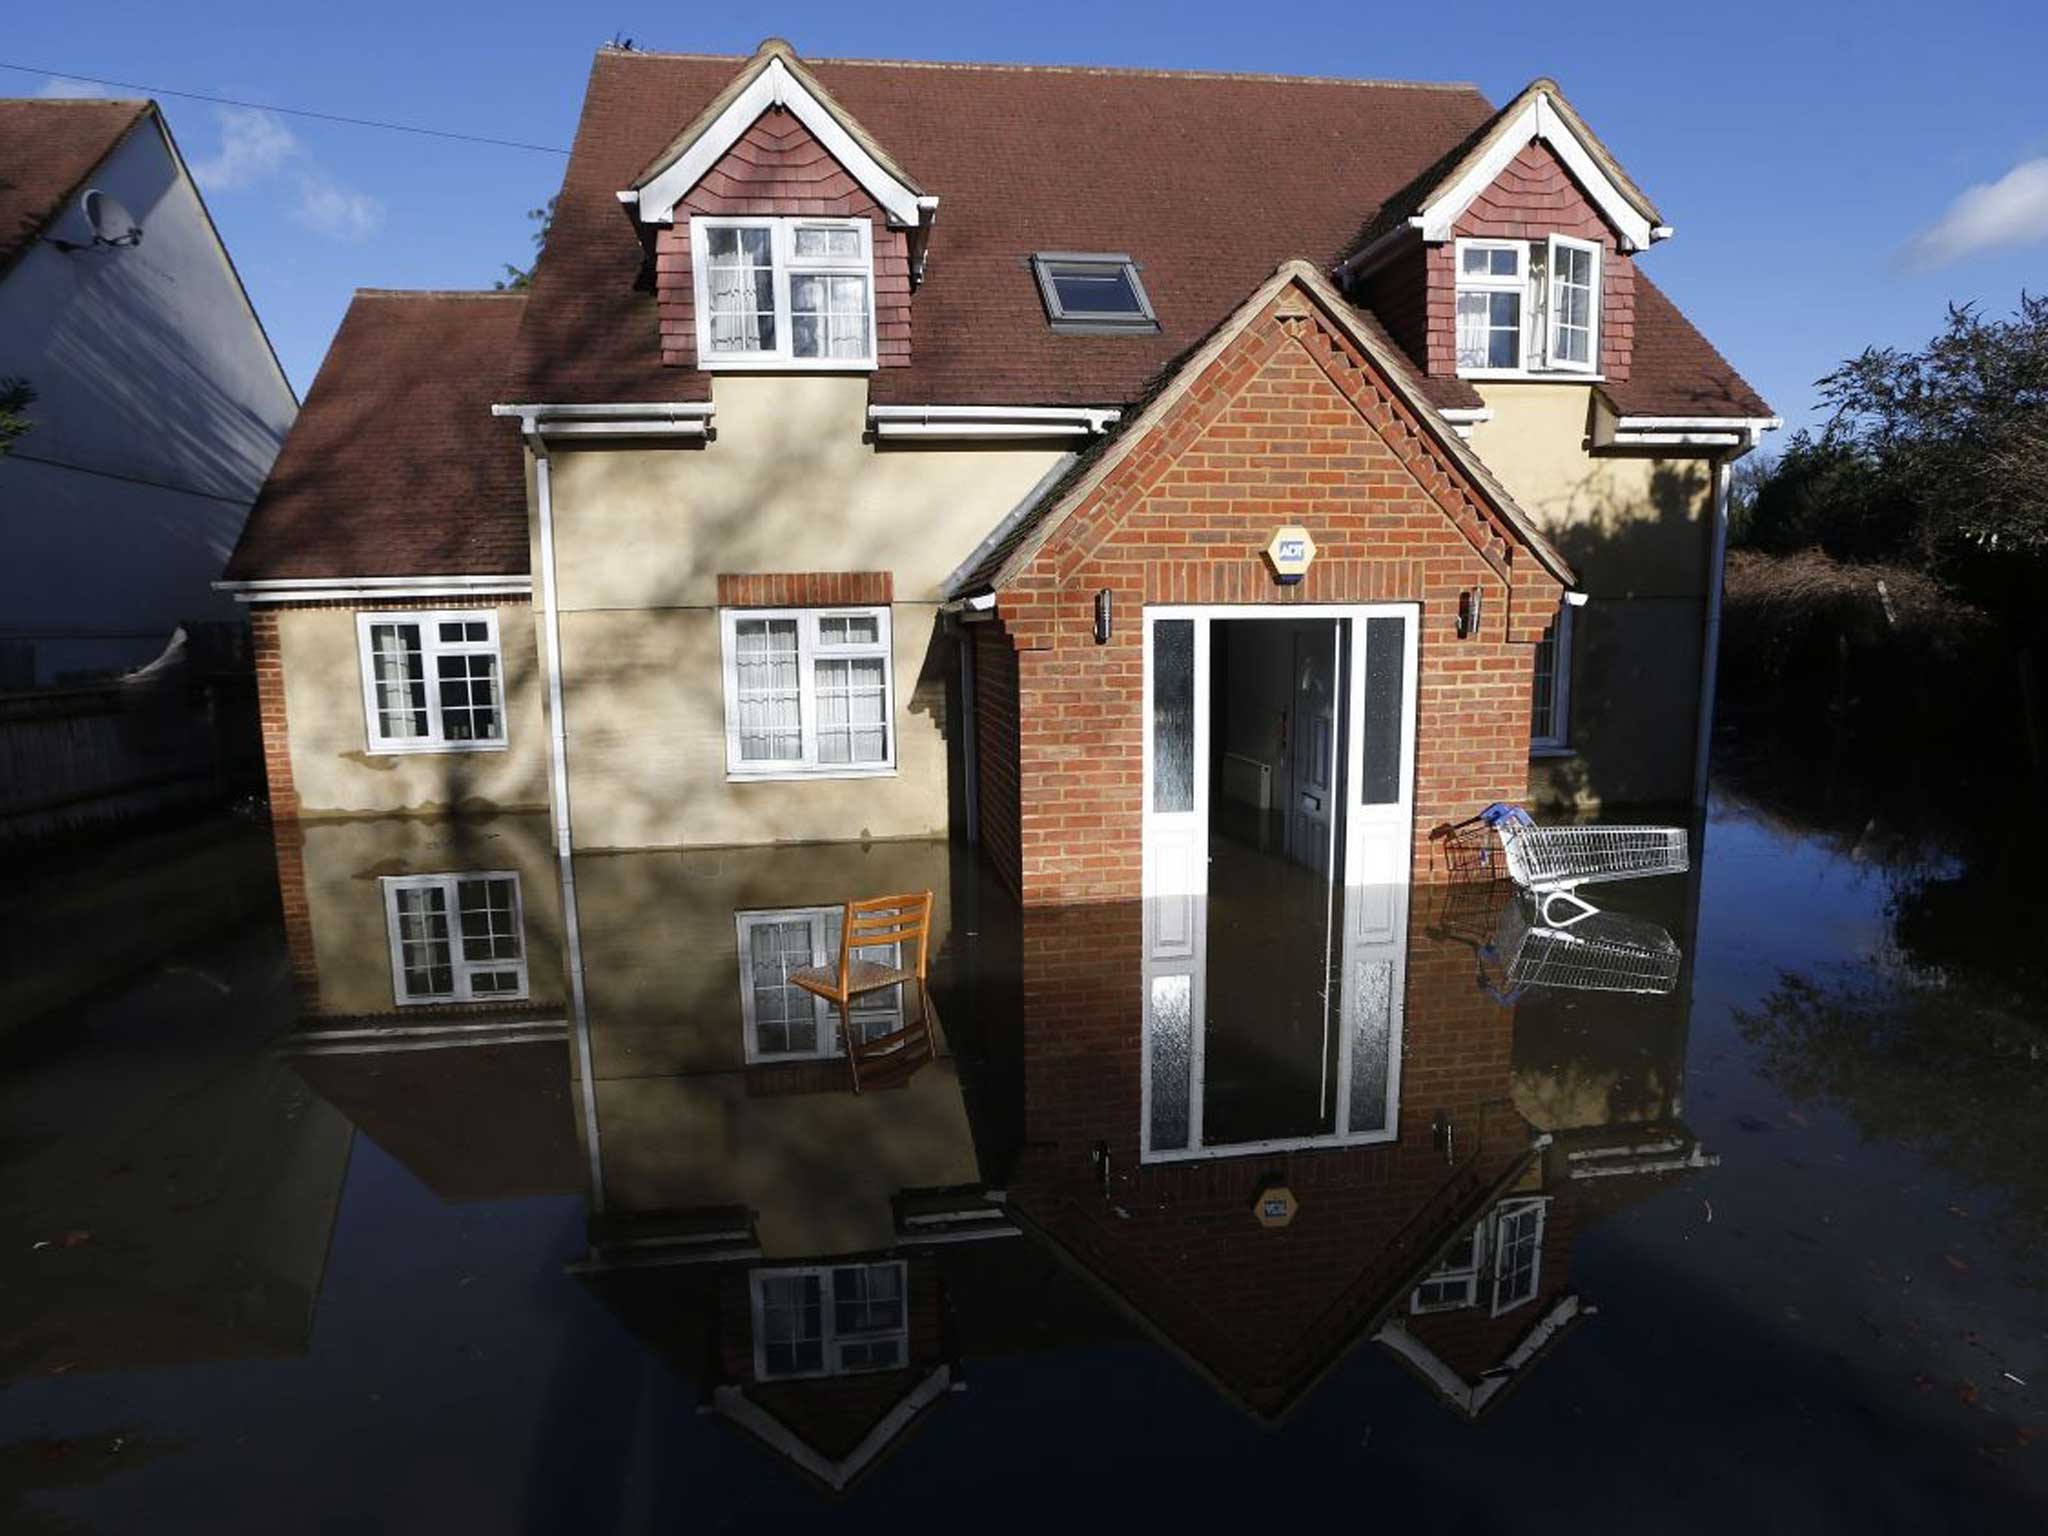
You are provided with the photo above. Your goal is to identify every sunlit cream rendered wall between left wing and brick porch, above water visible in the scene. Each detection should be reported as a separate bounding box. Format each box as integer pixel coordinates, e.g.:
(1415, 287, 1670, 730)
(551, 375, 1063, 848)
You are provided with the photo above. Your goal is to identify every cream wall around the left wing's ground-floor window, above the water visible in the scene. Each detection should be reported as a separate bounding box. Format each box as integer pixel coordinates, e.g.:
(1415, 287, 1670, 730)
(276, 602, 547, 817)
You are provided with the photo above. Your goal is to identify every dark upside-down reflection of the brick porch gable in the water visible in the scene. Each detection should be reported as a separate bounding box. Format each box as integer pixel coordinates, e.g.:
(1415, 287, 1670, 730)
(1010, 889, 1563, 1411)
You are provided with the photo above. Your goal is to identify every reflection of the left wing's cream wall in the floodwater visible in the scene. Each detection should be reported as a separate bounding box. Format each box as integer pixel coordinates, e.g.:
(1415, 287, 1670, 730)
(301, 815, 565, 1018)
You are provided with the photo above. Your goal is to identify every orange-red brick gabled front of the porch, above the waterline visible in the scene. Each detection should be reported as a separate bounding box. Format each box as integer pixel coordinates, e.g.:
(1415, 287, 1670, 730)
(997, 289, 1559, 905)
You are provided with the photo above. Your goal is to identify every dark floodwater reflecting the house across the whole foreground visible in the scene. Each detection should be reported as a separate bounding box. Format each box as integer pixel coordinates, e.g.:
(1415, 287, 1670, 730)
(0, 795, 2048, 1532)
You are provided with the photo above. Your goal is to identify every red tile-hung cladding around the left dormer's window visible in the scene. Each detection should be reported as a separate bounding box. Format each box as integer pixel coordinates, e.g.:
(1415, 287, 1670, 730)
(655, 106, 909, 369)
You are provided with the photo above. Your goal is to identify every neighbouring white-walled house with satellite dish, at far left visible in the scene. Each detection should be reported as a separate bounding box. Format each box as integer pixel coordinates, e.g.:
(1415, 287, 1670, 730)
(0, 100, 297, 690)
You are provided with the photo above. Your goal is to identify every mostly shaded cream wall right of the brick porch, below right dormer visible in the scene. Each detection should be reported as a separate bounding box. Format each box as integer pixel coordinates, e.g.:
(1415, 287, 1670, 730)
(1470, 383, 1714, 811)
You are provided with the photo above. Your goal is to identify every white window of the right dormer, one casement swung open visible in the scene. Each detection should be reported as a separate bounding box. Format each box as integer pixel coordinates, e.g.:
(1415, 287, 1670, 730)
(1456, 236, 1599, 377)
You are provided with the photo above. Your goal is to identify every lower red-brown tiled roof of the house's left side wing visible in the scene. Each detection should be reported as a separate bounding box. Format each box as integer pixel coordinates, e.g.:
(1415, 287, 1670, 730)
(227, 291, 528, 582)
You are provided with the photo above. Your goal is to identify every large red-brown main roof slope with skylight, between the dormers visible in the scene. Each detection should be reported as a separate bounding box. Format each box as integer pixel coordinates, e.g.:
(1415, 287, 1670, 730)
(510, 49, 1493, 406)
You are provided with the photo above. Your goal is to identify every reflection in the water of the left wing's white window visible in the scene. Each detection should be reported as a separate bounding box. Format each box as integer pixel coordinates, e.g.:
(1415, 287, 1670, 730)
(383, 870, 526, 1008)
